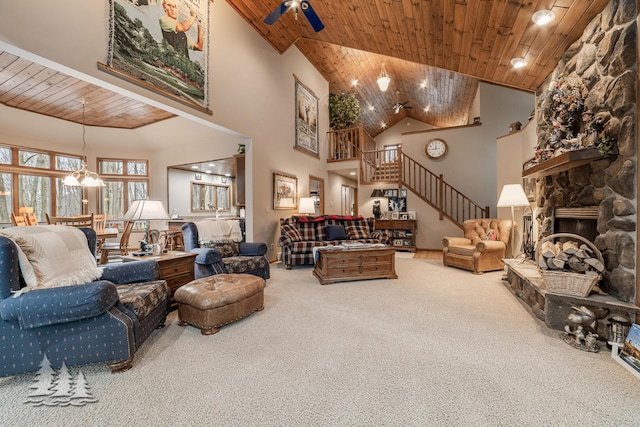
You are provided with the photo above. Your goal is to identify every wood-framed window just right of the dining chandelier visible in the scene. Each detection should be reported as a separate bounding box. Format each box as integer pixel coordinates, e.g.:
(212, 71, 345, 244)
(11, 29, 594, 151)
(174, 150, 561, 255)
(98, 159, 149, 220)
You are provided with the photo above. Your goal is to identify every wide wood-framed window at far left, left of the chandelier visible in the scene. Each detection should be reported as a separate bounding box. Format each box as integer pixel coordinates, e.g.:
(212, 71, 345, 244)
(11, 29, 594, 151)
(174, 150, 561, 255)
(0, 145, 84, 224)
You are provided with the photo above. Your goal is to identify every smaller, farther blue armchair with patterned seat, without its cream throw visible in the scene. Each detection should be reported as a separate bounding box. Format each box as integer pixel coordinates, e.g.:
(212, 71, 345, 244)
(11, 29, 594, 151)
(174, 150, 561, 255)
(182, 222, 271, 280)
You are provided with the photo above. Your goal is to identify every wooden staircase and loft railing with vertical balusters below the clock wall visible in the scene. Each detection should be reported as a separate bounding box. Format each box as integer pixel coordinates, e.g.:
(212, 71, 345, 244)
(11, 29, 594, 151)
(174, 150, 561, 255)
(327, 126, 490, 229)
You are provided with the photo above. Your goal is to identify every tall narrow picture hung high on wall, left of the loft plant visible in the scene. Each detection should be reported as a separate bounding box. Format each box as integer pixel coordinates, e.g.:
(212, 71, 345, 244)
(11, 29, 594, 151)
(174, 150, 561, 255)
(293, 78, 320, 158)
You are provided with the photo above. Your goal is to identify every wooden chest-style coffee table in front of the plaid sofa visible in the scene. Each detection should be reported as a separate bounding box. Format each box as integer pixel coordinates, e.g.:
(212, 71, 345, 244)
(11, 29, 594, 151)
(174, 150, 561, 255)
(313, 247, 398, 285)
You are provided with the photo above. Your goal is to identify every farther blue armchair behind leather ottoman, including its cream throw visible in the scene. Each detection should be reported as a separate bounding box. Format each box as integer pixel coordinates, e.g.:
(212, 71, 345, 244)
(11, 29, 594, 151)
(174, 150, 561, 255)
(182, 219, 271, 280)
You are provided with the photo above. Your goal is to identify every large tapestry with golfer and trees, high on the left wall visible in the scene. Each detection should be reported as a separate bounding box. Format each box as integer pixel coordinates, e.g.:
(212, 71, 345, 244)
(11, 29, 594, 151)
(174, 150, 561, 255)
(98, 0, 212, 114)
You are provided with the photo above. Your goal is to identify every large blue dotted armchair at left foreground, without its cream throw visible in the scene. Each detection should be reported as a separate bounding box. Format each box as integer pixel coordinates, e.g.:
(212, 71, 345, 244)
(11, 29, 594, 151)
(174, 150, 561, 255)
(0, 228, 169, 377)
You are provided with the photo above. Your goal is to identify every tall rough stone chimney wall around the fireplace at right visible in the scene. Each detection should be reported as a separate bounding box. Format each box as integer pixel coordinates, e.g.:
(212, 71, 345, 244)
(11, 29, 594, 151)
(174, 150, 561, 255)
(536, 0, 638, 302)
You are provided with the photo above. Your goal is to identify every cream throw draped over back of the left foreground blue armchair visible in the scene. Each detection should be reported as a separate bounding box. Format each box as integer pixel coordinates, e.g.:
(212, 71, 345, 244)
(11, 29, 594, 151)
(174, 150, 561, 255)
(0, 225, 102, 288)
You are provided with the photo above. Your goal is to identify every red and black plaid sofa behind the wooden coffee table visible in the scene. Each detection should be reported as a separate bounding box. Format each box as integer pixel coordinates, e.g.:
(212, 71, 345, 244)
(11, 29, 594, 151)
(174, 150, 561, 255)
(278, 215, 388, 270)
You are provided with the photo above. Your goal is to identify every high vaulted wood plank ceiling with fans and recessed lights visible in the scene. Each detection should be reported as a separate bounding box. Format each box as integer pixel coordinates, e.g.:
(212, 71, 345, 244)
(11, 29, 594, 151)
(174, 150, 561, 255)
(227, 0, 609, 136)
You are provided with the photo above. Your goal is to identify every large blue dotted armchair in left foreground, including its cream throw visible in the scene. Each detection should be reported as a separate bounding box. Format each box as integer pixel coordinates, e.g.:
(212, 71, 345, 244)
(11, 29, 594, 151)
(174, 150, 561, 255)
(0, 225, 169, 377)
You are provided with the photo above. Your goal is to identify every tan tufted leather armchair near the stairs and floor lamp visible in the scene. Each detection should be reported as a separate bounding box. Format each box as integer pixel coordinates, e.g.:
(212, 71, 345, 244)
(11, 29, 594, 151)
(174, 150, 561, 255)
(442, 218, 511, 274)
